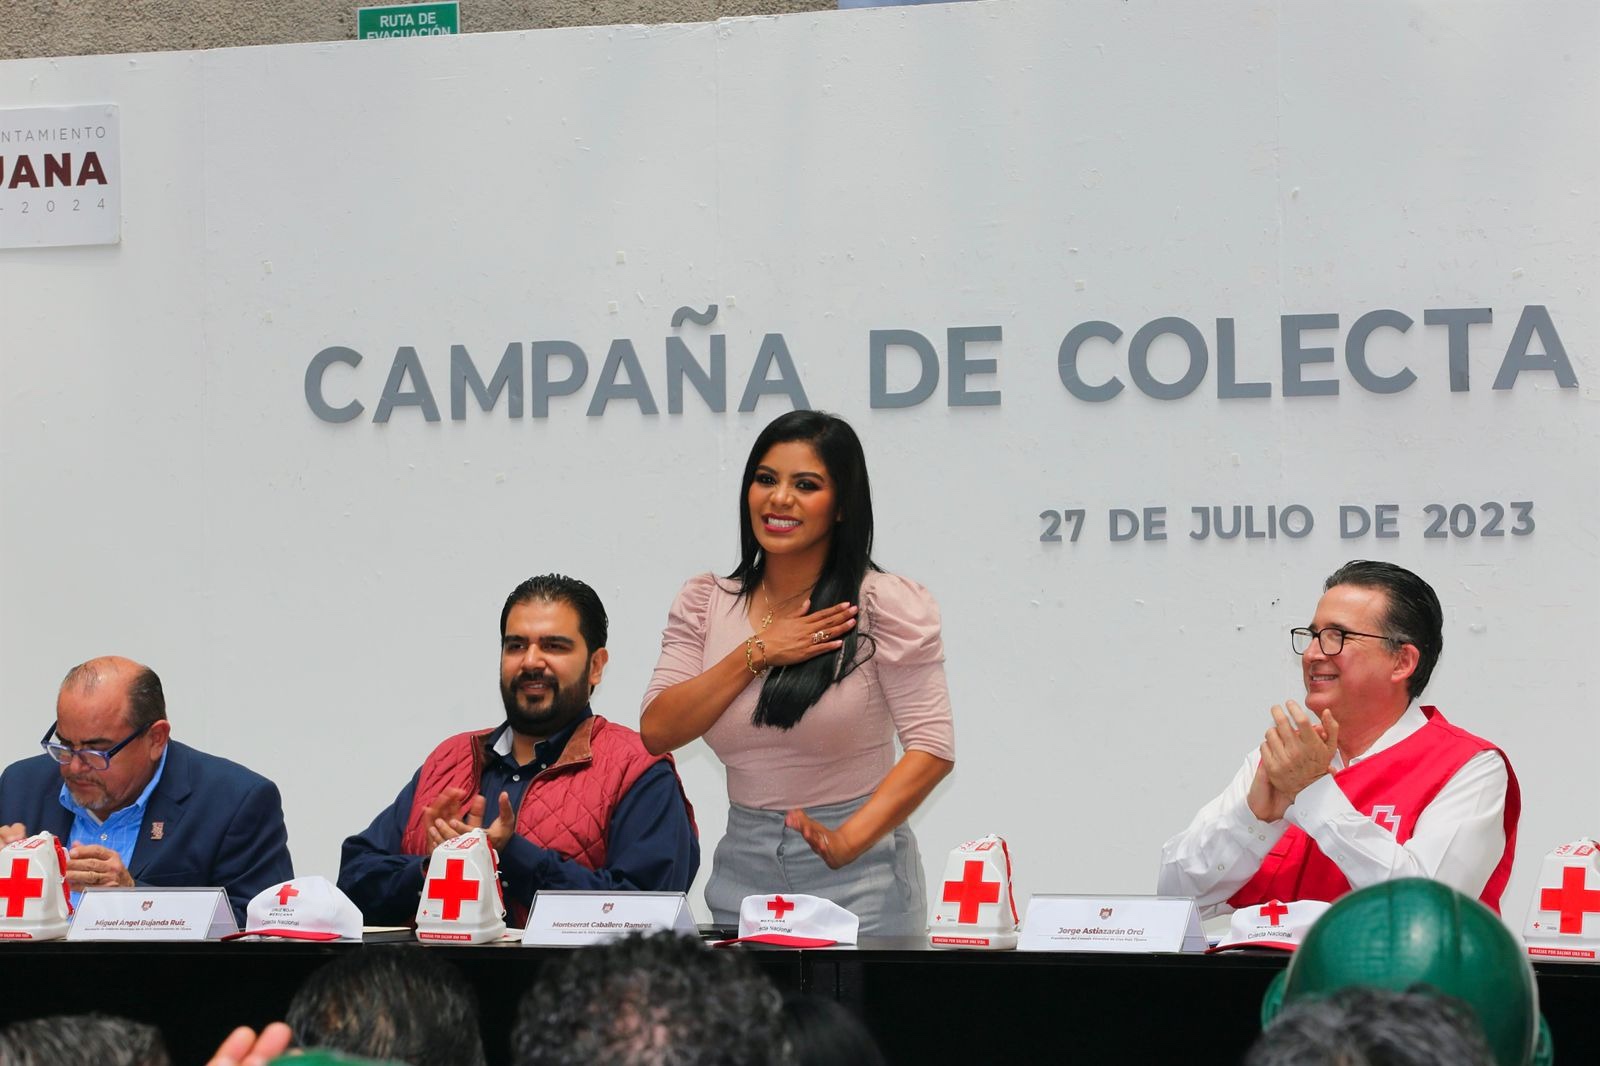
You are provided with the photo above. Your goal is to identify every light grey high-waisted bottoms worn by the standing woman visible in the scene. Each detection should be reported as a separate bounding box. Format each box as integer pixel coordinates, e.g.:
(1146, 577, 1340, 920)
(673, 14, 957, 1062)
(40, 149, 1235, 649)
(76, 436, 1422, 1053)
(706, 795, 928, 936)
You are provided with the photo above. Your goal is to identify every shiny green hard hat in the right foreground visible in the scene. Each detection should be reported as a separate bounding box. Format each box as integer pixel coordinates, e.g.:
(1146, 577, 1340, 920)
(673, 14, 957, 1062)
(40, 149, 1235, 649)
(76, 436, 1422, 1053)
(1261, 877, 1555, 1066)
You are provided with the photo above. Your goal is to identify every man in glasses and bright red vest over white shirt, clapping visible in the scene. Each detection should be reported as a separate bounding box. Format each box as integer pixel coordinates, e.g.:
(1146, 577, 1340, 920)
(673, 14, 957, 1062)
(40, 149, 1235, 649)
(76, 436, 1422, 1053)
(1158, 560, 1522, 917)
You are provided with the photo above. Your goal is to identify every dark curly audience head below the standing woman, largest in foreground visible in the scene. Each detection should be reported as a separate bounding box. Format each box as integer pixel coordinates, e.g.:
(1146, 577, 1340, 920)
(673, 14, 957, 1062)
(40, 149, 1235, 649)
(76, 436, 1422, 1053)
(510, 933, 786, 1066)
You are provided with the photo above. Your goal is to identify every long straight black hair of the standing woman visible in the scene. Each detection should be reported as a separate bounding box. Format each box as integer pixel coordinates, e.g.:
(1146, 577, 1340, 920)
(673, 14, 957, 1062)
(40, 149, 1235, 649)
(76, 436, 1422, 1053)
(728, 403, 878, 730)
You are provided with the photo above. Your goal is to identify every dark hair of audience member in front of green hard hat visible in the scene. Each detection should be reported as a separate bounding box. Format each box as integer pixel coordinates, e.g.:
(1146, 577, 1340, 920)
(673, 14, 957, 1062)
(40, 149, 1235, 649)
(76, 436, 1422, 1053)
(1245, 984, 1494, 1066)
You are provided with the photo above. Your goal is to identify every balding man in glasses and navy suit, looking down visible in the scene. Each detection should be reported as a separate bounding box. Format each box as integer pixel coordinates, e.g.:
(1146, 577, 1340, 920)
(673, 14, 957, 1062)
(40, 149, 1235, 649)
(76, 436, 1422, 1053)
(0, 656, 294, 924)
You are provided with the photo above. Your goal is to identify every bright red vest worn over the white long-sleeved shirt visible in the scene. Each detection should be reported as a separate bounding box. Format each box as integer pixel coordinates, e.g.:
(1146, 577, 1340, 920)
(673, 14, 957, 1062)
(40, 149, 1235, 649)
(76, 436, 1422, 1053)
(1229, 707, 1522, 914)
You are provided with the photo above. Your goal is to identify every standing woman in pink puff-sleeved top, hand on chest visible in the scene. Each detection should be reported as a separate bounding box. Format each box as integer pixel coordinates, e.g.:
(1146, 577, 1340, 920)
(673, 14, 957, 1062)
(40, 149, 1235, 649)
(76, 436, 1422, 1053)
(638, 411, 955, 936)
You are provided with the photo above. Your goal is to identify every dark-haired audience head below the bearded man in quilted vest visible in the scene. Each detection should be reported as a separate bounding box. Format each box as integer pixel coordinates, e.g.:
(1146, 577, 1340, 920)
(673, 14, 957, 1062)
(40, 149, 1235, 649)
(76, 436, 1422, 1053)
(285, 944, 483, 1066)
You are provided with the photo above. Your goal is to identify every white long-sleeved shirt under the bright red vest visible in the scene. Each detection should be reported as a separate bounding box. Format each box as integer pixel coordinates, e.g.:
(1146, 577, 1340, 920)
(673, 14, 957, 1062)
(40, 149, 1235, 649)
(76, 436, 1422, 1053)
(1157, 704, 1507, 917)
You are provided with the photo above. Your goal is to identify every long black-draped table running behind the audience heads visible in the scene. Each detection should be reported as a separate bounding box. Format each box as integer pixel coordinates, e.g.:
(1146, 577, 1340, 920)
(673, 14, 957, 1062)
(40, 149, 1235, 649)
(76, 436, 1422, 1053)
(0, 938, 1600, 1066)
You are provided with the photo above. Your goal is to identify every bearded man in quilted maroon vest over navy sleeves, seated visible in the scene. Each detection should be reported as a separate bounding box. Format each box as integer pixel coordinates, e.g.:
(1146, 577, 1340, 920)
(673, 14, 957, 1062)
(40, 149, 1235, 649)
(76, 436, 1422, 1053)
(339, 575, 699, 925)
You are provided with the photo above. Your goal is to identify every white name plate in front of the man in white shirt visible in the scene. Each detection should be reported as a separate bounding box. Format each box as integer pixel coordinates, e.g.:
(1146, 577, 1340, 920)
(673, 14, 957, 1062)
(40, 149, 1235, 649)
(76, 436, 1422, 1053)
(1016, 895, 1206, 954)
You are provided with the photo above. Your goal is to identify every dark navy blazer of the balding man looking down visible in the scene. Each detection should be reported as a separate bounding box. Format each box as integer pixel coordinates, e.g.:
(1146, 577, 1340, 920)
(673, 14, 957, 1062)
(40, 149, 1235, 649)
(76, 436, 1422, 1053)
(0, 739, 294, 928)
